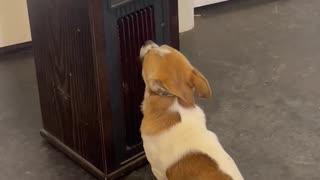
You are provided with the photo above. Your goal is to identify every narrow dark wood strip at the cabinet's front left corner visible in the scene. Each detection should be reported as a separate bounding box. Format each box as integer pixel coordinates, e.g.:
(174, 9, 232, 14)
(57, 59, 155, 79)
(88, 0, 115, 173)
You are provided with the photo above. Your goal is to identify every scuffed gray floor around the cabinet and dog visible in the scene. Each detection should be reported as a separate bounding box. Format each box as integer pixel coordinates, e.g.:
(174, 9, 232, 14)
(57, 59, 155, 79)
(0, 0, 320, 180)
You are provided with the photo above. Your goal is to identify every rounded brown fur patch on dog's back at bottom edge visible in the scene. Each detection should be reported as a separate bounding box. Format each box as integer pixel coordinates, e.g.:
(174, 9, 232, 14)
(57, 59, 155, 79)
(166, 153, 232, 180)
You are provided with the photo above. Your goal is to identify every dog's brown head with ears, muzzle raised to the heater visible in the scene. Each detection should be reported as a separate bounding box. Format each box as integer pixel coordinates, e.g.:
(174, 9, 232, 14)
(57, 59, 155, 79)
(140, 41, 211, 106)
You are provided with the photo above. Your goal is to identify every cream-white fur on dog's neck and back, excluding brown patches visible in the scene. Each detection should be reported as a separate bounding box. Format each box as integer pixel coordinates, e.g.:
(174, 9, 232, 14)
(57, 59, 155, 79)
(142, 100, 243, 180)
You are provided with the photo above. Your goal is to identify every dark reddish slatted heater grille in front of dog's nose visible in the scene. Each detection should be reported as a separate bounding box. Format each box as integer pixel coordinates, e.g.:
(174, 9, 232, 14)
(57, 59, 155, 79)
(118, 6, 155, 147)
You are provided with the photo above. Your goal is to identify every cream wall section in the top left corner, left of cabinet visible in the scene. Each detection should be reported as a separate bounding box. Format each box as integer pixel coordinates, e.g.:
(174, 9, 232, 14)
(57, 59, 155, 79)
(0, 0, 31, 47)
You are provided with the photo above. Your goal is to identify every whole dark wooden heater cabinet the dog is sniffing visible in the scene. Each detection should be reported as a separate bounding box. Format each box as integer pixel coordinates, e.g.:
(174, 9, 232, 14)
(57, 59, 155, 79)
(27, 0, 179, 179)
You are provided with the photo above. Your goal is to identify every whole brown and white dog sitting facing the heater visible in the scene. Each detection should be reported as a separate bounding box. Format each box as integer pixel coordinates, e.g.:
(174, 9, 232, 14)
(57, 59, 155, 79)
(140, 41, 243, 180)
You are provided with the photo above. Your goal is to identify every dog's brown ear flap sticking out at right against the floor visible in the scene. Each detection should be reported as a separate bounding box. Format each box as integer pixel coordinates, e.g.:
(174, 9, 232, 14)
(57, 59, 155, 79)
(191, 69, 212, 99)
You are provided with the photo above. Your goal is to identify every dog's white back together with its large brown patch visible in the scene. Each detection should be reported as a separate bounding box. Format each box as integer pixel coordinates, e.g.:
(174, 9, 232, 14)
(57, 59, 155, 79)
(142, 100, 243, 180)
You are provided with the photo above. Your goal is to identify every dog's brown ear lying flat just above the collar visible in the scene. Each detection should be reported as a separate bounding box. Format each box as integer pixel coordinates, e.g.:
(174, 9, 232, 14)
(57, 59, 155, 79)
(149, 79, 195, 106)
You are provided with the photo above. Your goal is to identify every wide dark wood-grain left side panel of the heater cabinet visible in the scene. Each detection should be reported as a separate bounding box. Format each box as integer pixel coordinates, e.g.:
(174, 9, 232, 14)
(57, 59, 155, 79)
(28, 0, 105, 171)
